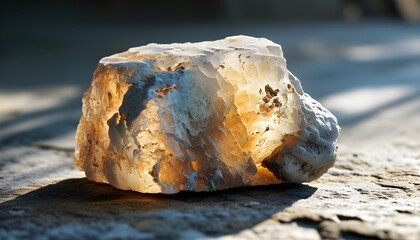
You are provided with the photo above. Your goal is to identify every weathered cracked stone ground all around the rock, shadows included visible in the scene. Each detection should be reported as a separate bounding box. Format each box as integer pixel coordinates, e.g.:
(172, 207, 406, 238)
(0, 23, 420, 239)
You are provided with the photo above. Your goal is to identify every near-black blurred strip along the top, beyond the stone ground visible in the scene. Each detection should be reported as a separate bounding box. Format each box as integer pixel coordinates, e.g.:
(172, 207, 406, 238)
(2, 0, 404, 24)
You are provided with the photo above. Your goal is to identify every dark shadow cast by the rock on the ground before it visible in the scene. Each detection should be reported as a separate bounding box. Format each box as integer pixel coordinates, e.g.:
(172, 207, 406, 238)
(0, 178, 316, 239)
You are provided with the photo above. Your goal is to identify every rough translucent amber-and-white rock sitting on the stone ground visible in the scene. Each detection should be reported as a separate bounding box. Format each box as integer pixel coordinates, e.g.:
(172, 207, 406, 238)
(75, 36, 339, 193)
